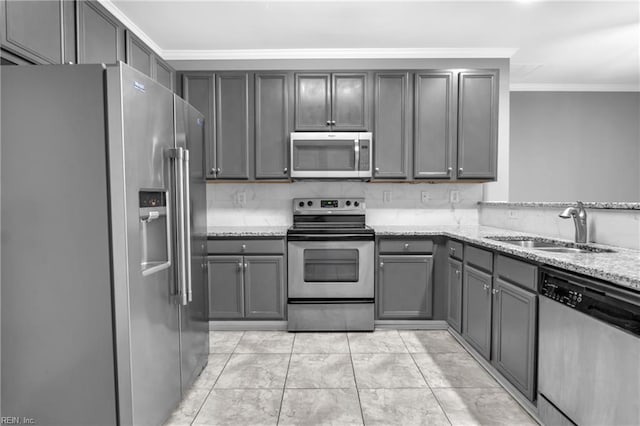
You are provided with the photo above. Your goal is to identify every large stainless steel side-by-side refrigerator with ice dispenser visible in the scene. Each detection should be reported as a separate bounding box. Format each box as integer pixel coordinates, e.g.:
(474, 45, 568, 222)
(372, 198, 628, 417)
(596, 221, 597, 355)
(0, 64, 209, 425)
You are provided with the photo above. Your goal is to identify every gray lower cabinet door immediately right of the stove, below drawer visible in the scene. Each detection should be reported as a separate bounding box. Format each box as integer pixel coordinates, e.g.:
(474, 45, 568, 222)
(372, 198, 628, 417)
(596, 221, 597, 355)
(376, 255, 433, 319)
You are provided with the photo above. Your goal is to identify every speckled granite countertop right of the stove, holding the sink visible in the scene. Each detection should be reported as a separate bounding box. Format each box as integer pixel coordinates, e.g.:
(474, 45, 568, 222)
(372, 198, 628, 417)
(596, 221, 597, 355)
(374, 225, 640, 292)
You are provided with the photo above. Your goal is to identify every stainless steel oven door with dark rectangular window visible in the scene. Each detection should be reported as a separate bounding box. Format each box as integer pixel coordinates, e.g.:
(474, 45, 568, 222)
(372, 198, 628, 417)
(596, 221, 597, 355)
(288, 235, 374, 300)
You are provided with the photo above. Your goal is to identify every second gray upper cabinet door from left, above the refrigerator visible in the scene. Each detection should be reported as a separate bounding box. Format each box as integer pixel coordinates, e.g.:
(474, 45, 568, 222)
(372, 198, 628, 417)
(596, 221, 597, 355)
(76, 0, 125, 64)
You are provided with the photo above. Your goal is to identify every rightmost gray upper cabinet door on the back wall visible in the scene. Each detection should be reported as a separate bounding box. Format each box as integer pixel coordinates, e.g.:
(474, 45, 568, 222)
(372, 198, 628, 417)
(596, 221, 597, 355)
(458, 71, 498, 179)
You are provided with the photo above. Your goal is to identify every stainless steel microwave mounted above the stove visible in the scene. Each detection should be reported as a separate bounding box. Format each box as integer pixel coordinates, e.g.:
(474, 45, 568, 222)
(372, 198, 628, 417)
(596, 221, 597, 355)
(291, 132, 373, 180)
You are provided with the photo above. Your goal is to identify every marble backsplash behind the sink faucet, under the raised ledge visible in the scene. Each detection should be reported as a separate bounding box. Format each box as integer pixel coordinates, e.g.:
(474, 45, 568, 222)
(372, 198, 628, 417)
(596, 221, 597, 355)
(478, 203, 640, 250)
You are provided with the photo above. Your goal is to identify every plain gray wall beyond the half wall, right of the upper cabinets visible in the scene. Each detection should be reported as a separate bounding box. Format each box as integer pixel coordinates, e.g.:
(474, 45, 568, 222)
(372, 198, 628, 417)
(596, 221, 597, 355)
(510, 92, 640, 201)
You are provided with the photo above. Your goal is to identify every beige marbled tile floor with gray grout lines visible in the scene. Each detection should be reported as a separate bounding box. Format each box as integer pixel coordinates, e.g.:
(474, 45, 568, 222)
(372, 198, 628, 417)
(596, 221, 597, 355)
(167, 330, 536, 426)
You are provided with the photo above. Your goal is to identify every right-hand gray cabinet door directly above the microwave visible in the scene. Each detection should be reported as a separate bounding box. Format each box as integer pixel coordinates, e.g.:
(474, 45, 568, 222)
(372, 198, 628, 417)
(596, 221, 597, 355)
(331, 73, 369, 132)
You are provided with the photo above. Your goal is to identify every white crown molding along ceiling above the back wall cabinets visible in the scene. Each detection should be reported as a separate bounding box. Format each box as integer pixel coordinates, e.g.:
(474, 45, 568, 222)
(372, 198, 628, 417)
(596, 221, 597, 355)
(163, 48, 518, 61)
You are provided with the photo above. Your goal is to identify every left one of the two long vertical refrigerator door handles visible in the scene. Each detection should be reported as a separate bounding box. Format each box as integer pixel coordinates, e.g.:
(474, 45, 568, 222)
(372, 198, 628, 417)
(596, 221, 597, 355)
(167, 147, 187, 305)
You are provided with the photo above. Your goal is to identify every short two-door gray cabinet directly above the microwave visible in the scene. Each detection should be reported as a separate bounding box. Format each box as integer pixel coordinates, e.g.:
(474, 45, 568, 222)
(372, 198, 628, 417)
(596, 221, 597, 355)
(295, 73, 368, 131)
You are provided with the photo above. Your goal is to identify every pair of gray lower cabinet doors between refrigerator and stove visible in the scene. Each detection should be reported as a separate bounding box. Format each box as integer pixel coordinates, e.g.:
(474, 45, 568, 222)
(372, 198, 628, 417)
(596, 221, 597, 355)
(208, 251, 286, 320)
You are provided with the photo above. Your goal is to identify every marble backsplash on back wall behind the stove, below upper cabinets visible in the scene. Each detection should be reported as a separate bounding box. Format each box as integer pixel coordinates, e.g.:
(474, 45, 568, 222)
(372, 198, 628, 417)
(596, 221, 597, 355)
(207, 181, 483, 227)
